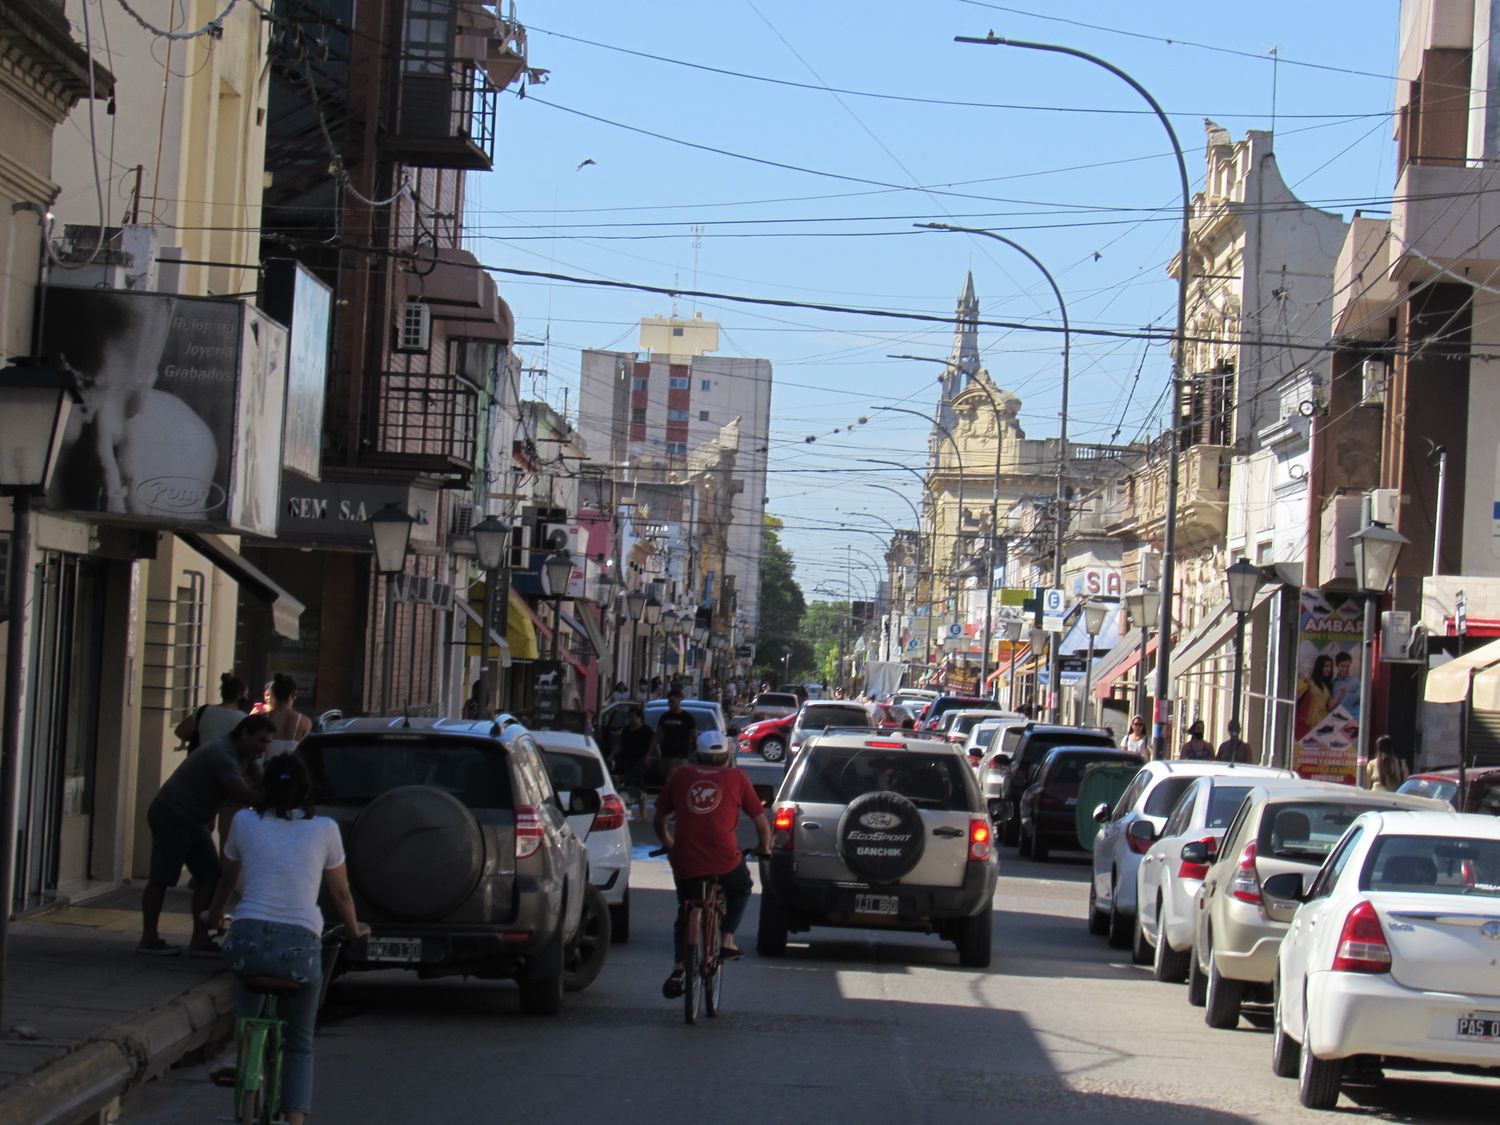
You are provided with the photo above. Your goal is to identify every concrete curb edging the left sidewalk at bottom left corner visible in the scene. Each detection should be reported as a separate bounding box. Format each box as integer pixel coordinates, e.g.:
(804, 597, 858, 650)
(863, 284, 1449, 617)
(0, 974, 234, 1125)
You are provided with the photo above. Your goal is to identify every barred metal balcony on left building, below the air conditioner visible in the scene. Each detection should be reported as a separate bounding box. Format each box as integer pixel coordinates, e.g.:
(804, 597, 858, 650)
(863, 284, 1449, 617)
(360, 372, 479, 488)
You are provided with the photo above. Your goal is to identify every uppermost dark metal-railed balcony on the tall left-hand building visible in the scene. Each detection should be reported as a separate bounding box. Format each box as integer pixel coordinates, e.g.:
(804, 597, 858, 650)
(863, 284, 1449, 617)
(381, 63, 500, 173)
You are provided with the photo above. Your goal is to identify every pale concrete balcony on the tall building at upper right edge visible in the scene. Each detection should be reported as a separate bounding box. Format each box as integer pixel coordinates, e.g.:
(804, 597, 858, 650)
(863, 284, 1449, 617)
(1386, 162, 1500, 282)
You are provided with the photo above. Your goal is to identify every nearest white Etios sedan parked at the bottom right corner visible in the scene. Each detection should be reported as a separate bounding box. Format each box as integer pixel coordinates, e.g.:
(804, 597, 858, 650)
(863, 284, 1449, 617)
(1263, 810, 1500, 1109)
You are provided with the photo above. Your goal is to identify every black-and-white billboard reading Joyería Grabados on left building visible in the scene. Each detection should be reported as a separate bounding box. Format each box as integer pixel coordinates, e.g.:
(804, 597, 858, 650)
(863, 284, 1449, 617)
(42, 287, 285, 534)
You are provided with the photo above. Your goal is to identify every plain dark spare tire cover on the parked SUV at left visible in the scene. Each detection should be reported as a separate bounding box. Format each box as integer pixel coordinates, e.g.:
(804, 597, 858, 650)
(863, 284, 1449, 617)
(348, 785, 485, 921)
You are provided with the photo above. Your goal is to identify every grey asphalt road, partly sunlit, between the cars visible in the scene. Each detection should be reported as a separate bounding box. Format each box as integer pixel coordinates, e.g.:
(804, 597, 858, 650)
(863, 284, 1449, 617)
(123, 851, 1500, 1125)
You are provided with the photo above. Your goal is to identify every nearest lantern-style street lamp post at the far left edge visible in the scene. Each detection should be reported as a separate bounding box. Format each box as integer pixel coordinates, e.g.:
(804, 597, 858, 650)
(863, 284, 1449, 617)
(0, 363, 80, 1020)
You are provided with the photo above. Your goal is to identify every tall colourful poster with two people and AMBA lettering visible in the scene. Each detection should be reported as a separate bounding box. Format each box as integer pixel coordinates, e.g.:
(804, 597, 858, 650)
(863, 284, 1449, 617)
(1292, 590, 1365, 785)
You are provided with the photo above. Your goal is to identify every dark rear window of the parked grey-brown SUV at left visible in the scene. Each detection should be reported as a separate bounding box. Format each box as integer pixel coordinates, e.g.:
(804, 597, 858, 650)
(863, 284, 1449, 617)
(302, 738, 513, 809)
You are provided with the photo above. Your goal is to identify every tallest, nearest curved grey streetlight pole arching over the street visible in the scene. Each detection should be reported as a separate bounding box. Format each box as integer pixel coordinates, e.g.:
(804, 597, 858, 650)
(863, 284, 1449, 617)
(957, 35, 1194, 758)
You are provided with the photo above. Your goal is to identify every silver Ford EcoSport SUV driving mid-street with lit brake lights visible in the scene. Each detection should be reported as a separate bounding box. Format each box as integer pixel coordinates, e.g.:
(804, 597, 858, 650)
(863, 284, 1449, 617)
(756, 732, 996, 969)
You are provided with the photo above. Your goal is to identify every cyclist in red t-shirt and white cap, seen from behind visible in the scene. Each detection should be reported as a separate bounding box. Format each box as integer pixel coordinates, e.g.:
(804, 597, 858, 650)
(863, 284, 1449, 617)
(656, 731, 771, 999)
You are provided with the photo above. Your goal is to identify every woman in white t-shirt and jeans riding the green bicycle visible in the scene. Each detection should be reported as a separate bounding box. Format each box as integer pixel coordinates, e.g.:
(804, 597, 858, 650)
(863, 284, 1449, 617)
(204, 755, 371, 1125)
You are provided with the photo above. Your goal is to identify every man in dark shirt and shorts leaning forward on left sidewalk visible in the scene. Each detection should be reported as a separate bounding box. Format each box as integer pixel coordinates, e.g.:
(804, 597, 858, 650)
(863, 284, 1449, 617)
(137, 714, 276, 954)
